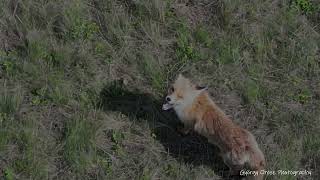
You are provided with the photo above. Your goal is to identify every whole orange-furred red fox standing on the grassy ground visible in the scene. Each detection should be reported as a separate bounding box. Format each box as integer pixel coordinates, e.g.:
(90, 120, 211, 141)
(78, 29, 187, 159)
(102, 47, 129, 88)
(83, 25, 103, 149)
(162, 74, 266, 180)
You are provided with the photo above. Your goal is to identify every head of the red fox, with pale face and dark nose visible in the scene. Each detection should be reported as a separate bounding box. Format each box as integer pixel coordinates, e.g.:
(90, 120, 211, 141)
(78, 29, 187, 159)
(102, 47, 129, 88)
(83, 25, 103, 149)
(162, 74, 207, 110)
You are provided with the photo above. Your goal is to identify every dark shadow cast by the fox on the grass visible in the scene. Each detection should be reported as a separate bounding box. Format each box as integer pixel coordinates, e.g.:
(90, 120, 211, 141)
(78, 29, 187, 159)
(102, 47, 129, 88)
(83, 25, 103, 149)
(100, 81, 232, 178)
